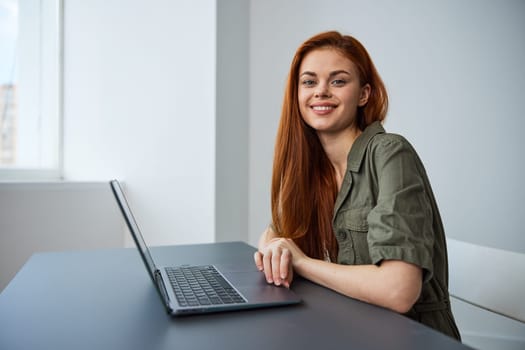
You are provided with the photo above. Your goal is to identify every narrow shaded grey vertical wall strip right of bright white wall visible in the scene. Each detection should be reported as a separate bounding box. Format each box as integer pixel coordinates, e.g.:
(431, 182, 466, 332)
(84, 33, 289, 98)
(215, 0, 250, 241)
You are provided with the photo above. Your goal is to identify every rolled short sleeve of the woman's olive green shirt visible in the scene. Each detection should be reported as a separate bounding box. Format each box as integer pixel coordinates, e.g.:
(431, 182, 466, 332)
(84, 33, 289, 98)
(367, 134, 434, 282)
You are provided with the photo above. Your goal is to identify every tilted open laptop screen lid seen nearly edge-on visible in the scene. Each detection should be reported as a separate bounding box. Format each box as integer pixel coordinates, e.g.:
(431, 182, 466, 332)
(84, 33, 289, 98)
(110, 180, 157, 282)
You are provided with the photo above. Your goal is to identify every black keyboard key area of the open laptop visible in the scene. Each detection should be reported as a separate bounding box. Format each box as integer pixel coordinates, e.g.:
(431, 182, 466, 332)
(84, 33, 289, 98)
(166, 265, 246, 306)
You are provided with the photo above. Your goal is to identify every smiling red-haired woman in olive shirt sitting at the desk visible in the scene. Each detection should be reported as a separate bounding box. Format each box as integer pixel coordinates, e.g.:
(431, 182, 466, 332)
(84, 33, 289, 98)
(255, 32, 460, 340)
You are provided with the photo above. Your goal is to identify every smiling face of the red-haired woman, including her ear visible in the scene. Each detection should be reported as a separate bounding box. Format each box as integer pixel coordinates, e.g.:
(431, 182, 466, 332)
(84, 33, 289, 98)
(298, 48, 370, 141)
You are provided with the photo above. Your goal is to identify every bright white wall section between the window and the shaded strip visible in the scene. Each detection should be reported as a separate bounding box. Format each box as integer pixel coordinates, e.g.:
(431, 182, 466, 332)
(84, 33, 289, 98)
(64, 0, 216, 245)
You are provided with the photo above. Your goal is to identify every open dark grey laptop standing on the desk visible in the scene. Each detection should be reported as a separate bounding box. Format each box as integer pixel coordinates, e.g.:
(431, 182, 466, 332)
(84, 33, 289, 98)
(110, 180, 301, 316)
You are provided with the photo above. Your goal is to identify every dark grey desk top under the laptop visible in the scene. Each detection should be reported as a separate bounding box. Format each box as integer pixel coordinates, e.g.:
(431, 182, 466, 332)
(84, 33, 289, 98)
(0, 242, 467, 350)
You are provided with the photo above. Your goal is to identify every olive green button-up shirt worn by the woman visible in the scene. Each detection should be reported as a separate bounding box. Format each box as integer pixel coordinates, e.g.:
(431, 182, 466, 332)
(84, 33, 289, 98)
(333, 122, 460, 339)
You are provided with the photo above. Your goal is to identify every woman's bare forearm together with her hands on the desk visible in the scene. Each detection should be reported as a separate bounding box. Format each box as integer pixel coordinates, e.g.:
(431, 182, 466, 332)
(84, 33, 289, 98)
(255, 235, 422, 313)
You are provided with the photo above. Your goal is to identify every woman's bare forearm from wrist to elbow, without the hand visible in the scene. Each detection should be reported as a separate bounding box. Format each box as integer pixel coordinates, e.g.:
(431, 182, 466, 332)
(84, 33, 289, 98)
(294, 258, 421, 313)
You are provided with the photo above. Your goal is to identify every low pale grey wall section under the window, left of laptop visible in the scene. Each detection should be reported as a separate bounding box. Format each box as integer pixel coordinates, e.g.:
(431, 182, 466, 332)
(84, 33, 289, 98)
(0, 182, 124, 292)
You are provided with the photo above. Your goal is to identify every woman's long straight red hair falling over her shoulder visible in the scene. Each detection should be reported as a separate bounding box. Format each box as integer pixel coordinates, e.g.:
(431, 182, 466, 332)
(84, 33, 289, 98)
(271, 31, 388, 261)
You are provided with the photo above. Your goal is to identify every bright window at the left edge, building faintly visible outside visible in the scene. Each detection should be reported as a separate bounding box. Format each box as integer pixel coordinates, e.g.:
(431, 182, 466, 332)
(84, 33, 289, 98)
(0, 0, 62, 181)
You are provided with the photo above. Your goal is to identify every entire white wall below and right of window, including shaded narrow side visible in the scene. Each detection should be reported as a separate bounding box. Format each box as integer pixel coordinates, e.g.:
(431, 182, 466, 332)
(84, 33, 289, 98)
(0, 0, 249, 290)
